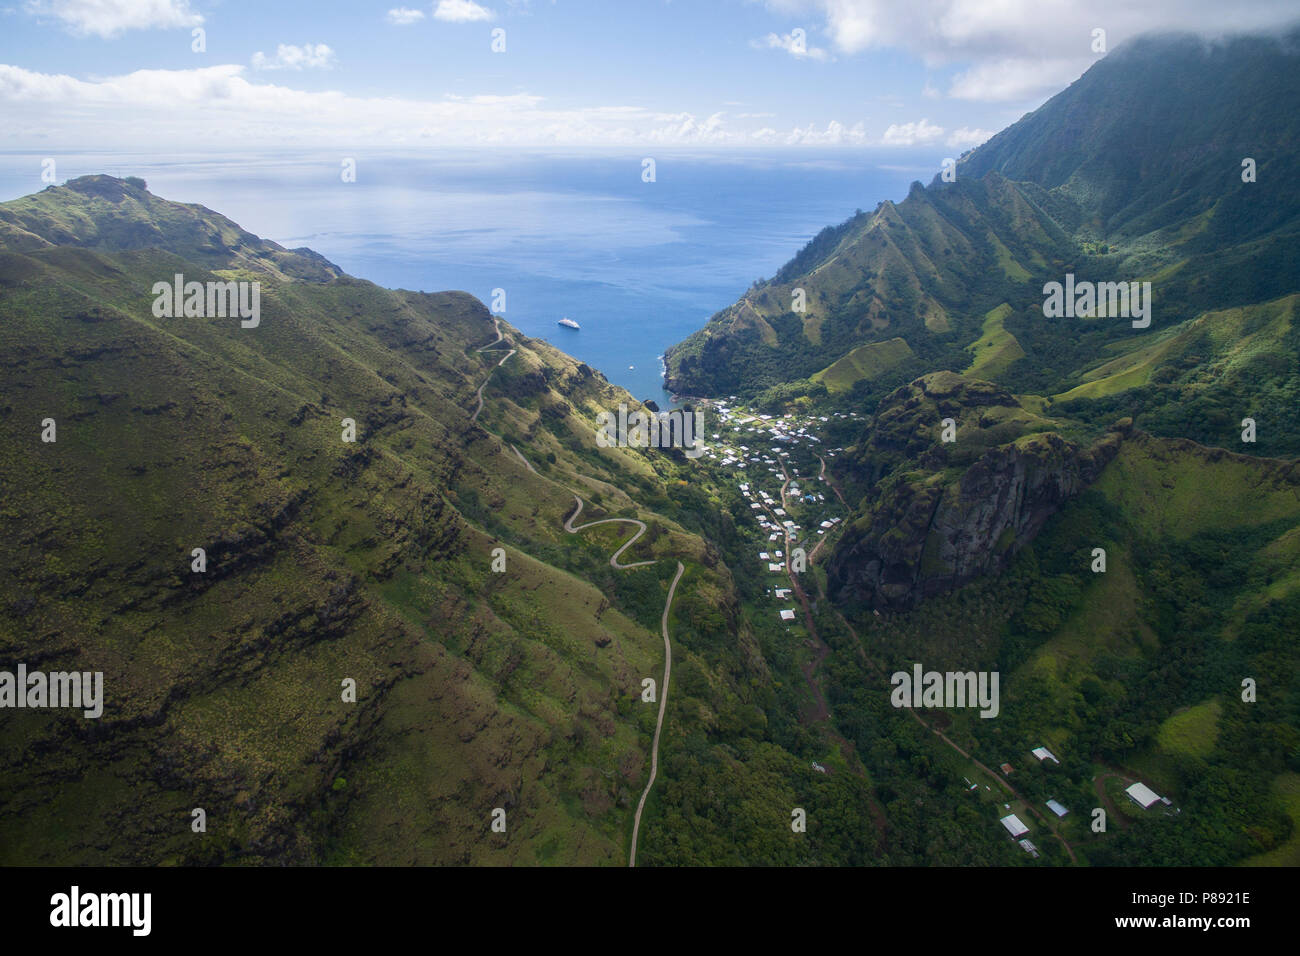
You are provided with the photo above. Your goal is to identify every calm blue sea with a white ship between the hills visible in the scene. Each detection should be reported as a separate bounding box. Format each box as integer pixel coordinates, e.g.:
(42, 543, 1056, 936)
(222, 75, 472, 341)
(0, 148, 941, 405)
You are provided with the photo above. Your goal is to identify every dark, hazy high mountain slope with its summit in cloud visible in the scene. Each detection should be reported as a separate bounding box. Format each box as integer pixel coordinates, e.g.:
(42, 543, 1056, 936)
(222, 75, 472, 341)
(961, 34, 1300, 244)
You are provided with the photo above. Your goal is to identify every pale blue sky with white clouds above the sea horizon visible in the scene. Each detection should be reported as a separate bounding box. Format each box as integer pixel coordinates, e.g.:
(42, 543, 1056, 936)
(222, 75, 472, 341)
(0, 0, 1297, 156)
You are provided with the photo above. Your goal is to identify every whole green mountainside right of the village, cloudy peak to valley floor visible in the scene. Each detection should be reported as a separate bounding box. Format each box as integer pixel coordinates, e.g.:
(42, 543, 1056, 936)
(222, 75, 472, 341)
(655, 31, 1300, 866)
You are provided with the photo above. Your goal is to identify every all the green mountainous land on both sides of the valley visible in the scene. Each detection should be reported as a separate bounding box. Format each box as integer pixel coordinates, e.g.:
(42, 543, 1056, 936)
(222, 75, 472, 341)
(0, 20, 1300, 866)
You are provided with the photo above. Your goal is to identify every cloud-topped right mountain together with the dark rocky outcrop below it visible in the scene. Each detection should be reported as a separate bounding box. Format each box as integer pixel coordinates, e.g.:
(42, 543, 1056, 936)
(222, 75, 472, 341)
(667, 33, 1300, 621)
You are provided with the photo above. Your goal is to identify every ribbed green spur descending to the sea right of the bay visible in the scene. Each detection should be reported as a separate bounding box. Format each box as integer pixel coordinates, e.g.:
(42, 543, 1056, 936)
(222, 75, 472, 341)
(666, 174, 1073, 394)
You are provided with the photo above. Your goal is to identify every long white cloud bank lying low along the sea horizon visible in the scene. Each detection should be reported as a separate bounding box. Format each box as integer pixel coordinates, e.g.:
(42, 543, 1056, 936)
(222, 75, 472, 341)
(0, 65, 889, 151)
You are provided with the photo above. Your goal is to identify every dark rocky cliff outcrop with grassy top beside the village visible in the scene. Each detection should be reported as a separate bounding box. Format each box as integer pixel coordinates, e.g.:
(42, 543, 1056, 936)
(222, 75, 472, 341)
(828, 373, 1128, 609)
